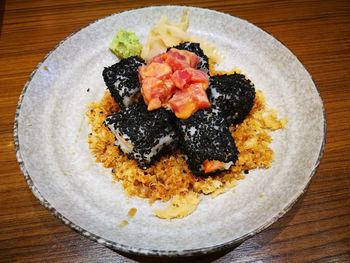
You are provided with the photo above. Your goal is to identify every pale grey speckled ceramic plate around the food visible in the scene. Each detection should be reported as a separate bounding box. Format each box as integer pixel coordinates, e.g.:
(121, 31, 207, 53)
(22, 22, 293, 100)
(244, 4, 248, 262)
(15, 6, 325, 256)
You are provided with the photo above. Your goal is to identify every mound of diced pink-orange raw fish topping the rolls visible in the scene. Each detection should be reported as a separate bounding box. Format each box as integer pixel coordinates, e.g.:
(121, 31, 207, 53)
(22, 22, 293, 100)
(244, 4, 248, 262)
(139, 48, 210, 119)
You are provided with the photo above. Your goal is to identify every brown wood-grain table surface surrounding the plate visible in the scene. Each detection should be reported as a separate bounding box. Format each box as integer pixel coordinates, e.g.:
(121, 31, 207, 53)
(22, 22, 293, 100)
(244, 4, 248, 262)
(0, 0, 350, 262)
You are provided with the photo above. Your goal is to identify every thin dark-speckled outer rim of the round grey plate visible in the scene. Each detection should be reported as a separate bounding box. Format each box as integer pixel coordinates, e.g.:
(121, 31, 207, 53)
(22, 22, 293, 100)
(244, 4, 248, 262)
(13, 5, 327, 257)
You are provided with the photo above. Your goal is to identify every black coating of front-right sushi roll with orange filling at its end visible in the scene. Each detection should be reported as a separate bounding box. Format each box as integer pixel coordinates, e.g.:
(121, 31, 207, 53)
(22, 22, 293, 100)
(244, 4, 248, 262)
(176, 107, 238, 176)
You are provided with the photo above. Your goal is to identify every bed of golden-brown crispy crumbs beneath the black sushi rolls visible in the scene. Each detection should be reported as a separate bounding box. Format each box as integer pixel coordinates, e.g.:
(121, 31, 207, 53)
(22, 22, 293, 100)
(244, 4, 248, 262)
(86, 85, 287, 218)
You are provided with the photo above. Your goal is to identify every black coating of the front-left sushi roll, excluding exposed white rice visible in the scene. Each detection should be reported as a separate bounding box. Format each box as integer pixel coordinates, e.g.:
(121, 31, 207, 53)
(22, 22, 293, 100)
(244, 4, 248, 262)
(105, 101, 177, 169)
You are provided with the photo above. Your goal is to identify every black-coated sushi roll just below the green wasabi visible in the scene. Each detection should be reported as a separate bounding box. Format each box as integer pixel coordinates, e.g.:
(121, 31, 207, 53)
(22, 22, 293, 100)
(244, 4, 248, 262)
(102, 56, 145, 108)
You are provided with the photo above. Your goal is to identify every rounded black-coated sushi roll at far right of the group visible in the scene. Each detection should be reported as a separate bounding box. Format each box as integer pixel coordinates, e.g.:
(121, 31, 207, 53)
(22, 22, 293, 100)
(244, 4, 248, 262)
(208, 73, 255, 124)
